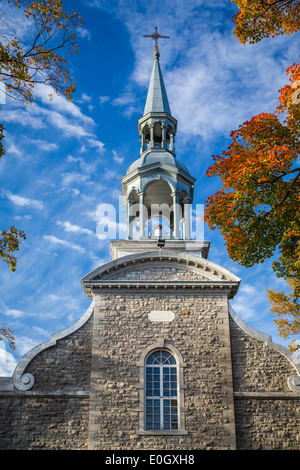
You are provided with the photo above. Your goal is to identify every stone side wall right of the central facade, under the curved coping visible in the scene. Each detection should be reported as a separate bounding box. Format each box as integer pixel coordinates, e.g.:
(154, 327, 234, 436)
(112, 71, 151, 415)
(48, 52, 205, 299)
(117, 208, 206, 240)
(230, 319, 300, 450)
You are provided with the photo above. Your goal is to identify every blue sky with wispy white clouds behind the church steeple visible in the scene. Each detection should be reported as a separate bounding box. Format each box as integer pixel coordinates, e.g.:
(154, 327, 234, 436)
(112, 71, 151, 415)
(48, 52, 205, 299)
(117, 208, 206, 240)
(0, 0, 299, 376)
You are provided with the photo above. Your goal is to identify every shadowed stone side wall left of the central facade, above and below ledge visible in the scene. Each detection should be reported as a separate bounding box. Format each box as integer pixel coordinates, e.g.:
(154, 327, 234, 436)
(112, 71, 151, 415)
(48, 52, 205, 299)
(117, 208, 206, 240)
(0, 312, 93, 450)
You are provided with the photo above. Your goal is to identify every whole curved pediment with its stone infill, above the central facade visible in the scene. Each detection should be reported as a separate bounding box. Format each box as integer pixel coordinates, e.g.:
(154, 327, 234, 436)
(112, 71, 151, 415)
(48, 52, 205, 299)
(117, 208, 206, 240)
(81, 251, 240, 298)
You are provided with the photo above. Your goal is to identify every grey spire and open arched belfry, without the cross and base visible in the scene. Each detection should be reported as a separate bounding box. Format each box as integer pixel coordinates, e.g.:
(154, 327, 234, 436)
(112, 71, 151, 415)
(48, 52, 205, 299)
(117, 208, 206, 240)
(122, 42, 195, 240)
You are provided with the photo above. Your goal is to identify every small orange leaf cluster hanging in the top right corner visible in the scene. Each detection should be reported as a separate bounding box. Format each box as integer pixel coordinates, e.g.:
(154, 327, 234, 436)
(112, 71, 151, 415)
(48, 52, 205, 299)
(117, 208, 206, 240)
(231, 0, 300, 44)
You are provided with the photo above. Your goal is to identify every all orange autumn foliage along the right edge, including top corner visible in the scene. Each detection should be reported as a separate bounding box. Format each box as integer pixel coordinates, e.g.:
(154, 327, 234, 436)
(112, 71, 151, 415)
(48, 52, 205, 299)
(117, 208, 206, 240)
(205, 0, 300, 349)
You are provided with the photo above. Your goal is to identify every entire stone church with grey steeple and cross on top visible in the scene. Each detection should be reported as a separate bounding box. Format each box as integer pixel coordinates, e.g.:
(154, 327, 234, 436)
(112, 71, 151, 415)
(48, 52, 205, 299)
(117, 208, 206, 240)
(0, 31, 300, 451)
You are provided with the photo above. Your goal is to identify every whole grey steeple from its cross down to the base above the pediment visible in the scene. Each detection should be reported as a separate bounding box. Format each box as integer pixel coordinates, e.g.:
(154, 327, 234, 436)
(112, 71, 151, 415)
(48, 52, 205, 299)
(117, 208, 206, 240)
(111, 28, 209, 259)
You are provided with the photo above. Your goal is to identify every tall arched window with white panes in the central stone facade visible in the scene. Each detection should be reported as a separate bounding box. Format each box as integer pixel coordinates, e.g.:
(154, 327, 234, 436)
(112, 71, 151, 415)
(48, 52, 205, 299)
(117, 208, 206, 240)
(145, 349, 178, 431)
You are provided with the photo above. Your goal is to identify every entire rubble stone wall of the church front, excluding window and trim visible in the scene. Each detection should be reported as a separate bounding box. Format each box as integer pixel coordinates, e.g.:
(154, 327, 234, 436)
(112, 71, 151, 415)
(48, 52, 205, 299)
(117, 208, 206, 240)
(0, 267, 300, 450)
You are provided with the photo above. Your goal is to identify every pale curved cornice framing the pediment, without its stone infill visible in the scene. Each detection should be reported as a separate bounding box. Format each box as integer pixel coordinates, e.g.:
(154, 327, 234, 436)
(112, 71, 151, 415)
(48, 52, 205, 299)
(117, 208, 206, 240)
(81, 251, 240, 298)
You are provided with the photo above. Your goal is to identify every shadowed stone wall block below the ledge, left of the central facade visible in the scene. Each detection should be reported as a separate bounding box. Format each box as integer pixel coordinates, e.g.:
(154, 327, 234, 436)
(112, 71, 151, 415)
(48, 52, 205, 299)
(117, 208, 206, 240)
(0, 392, 89, 450)
